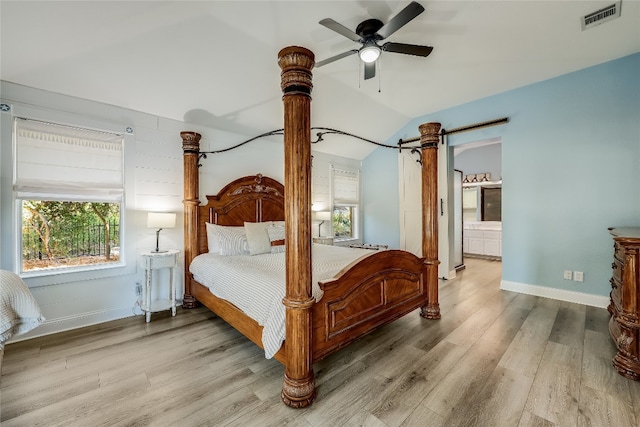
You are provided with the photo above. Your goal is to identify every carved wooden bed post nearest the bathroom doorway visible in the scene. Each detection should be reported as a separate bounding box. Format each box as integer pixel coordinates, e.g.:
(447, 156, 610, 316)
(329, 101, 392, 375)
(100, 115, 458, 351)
(418, 123, 441, 319)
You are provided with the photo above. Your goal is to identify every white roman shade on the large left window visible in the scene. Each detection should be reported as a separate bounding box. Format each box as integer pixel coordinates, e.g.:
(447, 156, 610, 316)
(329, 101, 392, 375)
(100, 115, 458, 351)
(14, 118, 124, 201)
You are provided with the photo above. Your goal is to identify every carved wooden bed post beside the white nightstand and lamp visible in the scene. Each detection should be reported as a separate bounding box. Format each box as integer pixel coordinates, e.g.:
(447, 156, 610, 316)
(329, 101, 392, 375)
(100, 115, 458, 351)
(180, 132, 201, 308)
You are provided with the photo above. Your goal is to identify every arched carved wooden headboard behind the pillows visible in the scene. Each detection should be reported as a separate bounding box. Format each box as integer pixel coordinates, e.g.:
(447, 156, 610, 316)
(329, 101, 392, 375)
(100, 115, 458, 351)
(198, 174, 284, 253)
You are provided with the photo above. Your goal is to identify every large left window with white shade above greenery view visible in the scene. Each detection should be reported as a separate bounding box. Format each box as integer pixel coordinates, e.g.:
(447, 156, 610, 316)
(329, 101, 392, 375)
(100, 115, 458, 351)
(14, 118, 124, 273)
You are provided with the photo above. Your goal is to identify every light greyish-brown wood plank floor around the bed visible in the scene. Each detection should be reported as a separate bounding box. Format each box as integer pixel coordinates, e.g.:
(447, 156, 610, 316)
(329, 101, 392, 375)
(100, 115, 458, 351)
(0, 259, 640, 427)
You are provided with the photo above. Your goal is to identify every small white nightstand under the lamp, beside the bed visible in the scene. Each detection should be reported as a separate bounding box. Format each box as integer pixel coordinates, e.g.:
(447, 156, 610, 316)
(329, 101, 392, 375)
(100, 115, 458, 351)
(140, 250, 180, 323)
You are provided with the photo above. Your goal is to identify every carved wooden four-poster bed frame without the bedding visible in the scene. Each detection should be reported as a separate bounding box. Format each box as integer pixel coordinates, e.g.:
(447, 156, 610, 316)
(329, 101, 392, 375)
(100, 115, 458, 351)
(181, 46, 440, 407)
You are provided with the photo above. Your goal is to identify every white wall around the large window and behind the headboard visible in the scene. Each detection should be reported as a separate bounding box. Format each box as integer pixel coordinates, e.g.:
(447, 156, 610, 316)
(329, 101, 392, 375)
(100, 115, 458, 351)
(0, 81, 360, 339)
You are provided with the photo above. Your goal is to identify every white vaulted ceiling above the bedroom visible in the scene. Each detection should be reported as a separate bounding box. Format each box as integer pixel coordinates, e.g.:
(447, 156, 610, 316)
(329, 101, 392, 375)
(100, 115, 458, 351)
(0, 0, 640, 158)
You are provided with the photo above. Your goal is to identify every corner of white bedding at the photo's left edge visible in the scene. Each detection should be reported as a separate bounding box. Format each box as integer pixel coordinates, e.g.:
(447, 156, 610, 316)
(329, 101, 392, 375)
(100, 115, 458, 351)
(0, 270, 44, 350)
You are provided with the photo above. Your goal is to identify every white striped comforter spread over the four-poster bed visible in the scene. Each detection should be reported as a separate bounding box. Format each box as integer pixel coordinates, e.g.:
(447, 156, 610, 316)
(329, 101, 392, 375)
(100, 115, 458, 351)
(189, 244, 375, 359)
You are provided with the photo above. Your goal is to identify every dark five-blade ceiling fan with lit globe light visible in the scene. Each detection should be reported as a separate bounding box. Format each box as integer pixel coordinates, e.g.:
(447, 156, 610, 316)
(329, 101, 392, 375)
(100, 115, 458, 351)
(316, 2, 433, 80)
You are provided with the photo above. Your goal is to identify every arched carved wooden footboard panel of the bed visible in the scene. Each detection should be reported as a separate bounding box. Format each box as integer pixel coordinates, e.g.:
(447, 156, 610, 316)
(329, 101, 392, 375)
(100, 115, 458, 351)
(312, 250, 428, 362)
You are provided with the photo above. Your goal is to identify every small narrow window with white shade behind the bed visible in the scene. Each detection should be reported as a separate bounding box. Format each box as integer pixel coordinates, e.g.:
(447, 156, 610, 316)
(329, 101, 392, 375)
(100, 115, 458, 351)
(331, 168, 360, 240)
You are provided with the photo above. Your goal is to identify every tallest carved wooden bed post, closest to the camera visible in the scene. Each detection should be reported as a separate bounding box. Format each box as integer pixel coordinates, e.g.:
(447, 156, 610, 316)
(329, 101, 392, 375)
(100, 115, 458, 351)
(278, 46, 316, 408)
